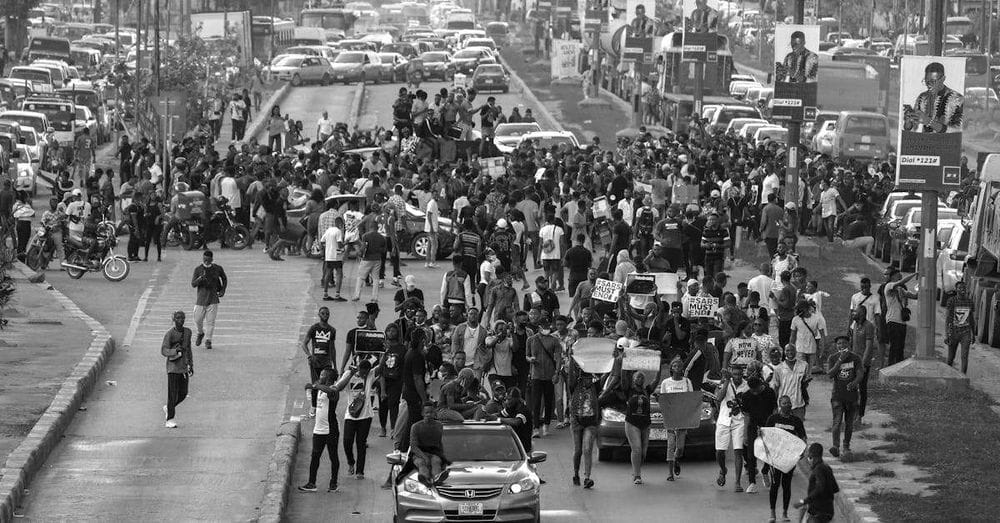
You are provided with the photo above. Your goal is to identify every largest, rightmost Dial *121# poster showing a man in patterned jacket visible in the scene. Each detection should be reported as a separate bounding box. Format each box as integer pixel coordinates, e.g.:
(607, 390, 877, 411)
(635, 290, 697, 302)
(896, 56, 965, 191)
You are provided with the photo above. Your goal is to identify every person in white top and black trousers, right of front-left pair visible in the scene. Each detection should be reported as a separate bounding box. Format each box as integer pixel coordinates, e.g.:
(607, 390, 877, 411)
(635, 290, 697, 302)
(344, 359, 376, 479)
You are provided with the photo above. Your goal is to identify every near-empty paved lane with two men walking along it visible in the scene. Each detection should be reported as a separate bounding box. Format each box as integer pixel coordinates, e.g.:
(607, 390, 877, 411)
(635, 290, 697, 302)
(24, 251, 310, 521)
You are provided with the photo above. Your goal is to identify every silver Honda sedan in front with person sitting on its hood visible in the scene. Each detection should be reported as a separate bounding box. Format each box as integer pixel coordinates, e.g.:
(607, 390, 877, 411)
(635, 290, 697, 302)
(386, 421, 546, 522)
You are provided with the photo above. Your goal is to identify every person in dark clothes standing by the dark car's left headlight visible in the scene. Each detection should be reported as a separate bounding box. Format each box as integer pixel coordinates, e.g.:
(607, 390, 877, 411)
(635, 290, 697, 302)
(566, 359, 601, 489)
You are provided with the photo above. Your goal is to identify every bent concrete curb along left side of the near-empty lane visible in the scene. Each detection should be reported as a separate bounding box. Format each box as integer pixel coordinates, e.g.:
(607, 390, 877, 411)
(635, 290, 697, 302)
(0, 262, 115, 523)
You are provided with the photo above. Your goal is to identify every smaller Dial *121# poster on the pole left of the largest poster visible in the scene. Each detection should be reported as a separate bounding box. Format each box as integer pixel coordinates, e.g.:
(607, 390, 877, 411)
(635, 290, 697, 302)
(771, 24, 820, 122)
